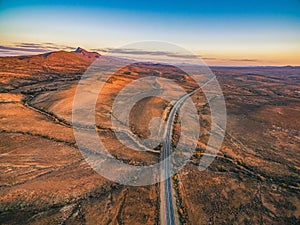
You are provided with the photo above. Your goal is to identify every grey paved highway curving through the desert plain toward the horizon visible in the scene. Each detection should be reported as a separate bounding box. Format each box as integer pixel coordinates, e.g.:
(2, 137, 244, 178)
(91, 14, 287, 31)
(160, 88, 200, 225)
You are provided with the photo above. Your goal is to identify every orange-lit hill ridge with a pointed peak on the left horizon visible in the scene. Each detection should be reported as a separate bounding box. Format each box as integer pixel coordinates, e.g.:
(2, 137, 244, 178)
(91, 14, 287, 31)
(0, 47, 101, 85)
